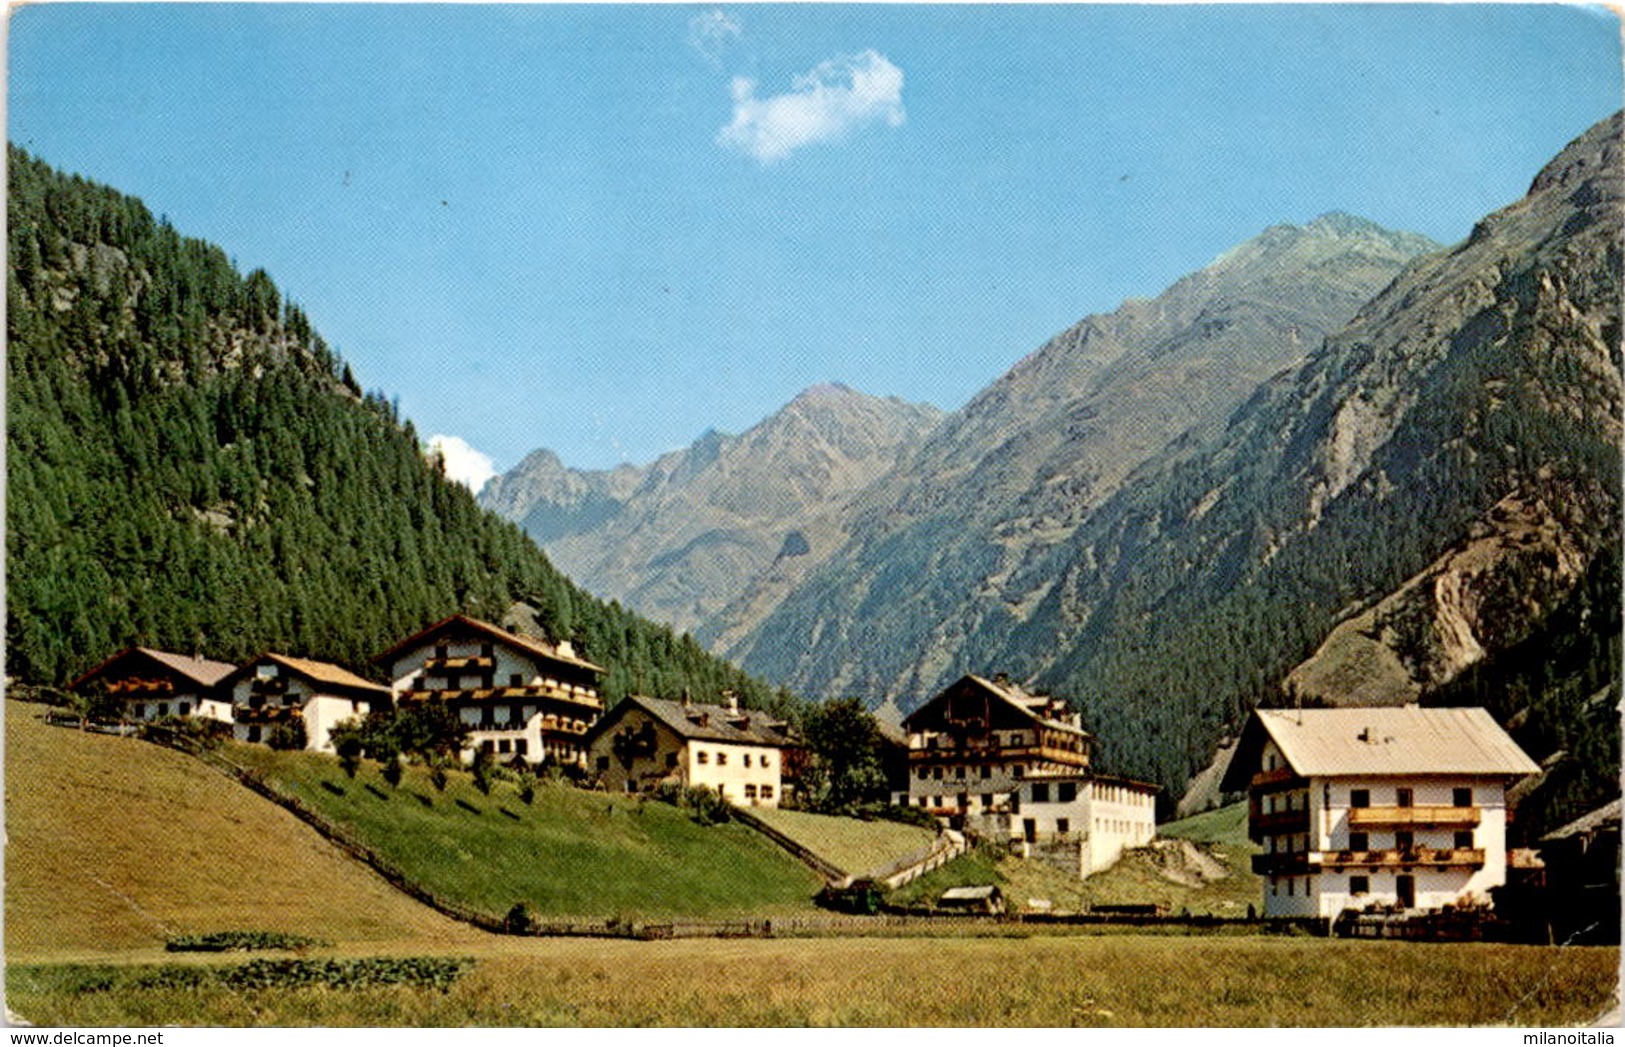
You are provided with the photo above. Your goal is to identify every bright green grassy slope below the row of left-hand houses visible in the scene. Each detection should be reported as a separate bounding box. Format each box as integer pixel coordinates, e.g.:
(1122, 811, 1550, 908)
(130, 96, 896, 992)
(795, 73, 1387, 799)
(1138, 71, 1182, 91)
(229, 745, 821, 917)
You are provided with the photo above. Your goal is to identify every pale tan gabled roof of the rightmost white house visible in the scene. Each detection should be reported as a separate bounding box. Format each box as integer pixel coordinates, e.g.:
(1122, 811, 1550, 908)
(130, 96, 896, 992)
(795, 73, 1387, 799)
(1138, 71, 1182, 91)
(1220, 706, 1541, 792)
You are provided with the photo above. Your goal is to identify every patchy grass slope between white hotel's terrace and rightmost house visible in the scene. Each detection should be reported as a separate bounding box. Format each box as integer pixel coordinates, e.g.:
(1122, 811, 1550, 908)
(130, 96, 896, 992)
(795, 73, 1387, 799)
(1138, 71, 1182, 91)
(892, 805, 1263, 915)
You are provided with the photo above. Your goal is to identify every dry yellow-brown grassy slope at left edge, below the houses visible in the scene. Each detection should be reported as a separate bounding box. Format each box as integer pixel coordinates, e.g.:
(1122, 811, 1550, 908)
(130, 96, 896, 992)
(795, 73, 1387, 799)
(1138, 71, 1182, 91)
(5, 702, 478, 961)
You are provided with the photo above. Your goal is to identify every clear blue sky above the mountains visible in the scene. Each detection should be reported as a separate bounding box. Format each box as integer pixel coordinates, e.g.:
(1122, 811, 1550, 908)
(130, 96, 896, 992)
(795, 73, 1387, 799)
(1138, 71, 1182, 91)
(8, 3, 1622, 481)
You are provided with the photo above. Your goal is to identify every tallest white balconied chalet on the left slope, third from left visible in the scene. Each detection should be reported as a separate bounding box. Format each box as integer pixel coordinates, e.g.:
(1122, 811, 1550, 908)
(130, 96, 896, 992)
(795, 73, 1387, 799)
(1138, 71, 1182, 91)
(374, 615, 605, 769)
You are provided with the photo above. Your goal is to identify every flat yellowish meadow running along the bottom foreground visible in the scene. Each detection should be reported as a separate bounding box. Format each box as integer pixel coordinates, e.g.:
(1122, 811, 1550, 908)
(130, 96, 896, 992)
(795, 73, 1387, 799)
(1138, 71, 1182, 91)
(7, 935, 1619, 1027)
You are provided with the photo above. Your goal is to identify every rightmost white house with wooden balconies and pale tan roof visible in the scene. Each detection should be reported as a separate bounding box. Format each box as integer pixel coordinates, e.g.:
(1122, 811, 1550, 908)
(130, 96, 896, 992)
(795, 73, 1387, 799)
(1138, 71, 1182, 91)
(1222, 706, 1539, 917)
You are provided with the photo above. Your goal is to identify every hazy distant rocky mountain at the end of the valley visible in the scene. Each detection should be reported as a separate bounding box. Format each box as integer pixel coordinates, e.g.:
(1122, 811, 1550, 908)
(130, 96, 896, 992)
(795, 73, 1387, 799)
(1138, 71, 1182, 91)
(481, 385, 941, 631)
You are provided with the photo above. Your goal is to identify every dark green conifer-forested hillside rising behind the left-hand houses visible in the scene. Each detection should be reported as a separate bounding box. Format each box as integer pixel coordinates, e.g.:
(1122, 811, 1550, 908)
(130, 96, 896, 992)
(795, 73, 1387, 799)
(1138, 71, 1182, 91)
(7, 146, 785, 706)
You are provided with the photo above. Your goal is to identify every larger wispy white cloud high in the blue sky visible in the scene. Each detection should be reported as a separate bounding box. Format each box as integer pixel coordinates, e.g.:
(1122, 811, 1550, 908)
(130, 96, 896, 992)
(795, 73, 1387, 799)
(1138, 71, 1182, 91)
(717, 50, 904, 164)
